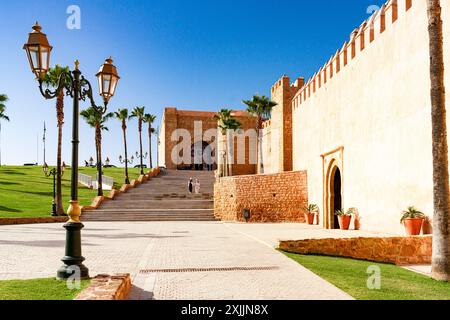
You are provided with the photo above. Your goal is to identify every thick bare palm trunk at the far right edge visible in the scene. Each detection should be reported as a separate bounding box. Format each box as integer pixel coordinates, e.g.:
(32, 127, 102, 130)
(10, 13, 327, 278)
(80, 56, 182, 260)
(427, 0, 450, 281)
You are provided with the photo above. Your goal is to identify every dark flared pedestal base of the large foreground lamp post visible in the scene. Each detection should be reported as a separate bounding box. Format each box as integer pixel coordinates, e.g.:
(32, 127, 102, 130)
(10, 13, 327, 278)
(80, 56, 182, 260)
(57, 222, 89, 280)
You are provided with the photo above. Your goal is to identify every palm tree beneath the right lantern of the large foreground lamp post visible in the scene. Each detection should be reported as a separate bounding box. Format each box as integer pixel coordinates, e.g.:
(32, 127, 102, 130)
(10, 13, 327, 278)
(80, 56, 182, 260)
(80, 107, 114, 197)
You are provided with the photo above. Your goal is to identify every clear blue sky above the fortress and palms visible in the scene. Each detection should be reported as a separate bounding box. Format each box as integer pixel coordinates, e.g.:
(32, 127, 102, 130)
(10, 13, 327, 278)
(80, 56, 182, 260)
(0, 0, 383, 164)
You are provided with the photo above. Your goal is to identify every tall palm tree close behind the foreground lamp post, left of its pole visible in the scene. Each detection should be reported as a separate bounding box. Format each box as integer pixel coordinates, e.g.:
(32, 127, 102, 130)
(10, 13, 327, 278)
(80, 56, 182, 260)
(43, 65, 69, 215)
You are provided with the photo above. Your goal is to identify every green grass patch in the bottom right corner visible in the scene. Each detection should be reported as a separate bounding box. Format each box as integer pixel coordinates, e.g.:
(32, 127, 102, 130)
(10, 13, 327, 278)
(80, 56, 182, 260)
(285, 253, 450, 300)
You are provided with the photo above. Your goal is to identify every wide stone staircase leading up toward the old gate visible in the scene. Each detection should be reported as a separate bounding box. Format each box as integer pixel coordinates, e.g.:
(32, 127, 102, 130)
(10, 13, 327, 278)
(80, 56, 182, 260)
(81, 170, 215, 221)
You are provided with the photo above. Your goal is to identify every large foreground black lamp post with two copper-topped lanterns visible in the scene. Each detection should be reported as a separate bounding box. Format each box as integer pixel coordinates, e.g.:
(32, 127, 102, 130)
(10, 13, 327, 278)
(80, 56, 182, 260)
(23, 22, 120, 279)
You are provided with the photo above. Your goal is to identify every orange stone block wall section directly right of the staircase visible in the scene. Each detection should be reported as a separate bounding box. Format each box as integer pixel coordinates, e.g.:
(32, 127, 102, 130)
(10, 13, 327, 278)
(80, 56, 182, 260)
(214, 171, 308, 222)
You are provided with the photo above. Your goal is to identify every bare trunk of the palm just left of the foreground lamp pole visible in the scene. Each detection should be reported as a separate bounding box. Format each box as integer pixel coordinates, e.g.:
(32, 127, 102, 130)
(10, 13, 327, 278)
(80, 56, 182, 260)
(56, 91, 65, 215)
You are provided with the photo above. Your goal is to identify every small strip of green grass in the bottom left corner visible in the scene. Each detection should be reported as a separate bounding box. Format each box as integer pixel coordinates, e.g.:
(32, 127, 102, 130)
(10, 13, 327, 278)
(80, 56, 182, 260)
(0, 278, 89, 300)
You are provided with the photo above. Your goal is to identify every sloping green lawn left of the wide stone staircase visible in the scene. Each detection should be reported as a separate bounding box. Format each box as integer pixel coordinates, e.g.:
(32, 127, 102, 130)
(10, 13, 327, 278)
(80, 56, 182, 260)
(0, 166, 140, 218)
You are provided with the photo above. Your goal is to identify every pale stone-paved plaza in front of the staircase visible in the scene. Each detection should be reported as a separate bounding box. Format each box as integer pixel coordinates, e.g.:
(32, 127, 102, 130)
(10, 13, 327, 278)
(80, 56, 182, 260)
(0, 222, 358, 300)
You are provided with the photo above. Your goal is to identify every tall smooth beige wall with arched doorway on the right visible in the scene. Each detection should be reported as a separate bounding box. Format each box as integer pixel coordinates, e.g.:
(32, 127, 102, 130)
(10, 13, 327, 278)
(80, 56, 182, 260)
(292, 0, 450, 234)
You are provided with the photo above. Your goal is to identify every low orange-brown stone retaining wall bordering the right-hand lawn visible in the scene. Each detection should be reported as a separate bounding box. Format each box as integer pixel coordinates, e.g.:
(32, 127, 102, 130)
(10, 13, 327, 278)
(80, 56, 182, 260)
(279, 236, 432, 265)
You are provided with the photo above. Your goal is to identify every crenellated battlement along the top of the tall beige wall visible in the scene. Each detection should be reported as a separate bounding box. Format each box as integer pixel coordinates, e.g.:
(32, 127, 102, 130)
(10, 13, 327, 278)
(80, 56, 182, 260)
(292, 0, 413, 109)
